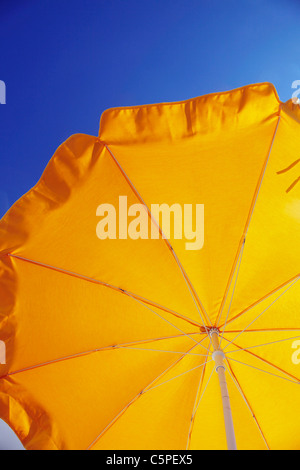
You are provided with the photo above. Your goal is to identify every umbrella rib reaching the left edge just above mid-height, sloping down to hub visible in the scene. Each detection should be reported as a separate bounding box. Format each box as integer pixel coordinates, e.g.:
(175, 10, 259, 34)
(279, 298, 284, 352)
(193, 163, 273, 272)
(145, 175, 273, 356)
(7, 253, 201, 328)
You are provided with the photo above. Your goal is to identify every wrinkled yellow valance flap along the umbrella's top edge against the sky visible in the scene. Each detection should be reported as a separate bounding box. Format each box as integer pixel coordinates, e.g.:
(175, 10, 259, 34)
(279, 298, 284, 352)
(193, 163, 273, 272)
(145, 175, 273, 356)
(100, 83, 280, 145)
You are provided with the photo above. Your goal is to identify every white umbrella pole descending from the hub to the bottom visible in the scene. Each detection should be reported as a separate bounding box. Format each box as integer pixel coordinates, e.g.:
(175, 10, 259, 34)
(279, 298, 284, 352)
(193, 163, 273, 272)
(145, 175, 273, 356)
(210, 329, 237, 450)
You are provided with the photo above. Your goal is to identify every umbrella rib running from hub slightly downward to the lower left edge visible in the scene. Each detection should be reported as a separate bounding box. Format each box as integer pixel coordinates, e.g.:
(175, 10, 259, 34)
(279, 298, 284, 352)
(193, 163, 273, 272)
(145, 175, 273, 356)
(0, 332, 205, 380)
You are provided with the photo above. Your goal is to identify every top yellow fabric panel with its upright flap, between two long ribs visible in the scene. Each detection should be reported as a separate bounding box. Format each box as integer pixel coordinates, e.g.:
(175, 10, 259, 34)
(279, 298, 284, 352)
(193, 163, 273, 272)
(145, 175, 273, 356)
(99, 85, 279, 324)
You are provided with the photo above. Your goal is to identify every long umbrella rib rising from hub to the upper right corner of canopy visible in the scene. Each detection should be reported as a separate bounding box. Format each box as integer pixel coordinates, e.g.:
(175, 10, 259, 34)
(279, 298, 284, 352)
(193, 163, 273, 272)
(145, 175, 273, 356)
(216, 108, 281, 324)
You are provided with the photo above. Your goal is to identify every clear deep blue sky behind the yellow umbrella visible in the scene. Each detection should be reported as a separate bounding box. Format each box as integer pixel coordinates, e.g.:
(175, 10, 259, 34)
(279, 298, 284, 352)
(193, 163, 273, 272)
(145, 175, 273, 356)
(0, 0, 300, 447)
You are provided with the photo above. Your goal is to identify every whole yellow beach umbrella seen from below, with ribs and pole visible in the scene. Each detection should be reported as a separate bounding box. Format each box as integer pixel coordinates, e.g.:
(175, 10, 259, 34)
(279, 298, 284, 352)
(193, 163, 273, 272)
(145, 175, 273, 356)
(0, 83, 300, 449)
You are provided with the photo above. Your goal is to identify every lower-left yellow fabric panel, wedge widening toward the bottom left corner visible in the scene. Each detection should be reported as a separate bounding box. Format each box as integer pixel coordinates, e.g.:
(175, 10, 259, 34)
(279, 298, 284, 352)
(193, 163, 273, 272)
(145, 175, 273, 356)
(1, 338, 203, 449)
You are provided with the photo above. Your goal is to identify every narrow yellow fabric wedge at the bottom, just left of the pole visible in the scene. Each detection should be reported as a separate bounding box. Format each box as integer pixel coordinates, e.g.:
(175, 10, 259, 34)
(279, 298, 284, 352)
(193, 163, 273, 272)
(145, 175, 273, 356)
(92, 340, 209, 450)
